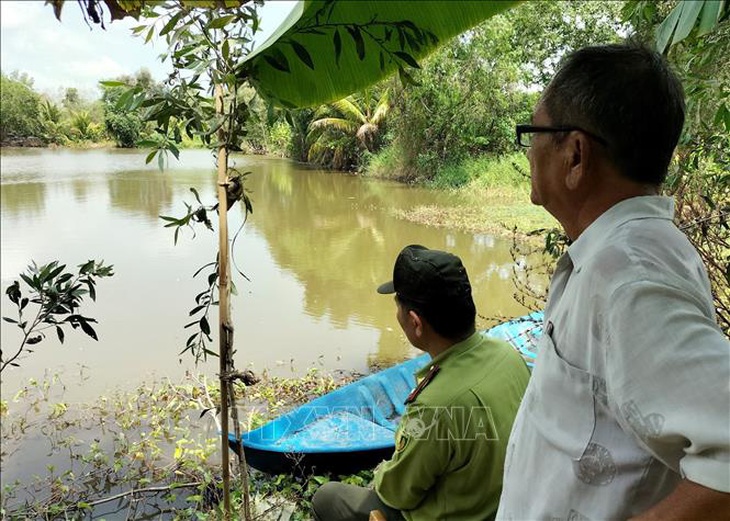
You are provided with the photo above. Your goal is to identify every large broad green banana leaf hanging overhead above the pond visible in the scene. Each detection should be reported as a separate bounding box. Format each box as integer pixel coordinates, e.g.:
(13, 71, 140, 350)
(240, 0, 516, 107)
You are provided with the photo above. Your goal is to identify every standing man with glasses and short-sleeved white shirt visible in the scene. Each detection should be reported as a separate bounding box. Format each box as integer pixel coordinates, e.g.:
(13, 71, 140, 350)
(497, 44, 730, 521)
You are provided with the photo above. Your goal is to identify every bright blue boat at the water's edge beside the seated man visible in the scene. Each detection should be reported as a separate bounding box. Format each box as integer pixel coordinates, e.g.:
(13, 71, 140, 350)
(229, 312, 543, 474)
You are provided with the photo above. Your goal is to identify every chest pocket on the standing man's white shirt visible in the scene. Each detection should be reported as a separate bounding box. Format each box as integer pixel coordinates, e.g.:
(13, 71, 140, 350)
(527, 334, 595, 460)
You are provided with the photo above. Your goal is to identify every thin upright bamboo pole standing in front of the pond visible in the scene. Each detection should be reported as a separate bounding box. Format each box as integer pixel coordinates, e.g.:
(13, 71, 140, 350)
(215, 85, 231, 520)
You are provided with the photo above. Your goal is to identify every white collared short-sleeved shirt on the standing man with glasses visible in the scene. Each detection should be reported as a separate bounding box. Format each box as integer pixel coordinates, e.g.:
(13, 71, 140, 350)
(497, 196, 730, 521)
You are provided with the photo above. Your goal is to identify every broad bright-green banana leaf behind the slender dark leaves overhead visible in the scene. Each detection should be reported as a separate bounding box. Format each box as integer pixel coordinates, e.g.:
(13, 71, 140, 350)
(247, 0, 517, 107)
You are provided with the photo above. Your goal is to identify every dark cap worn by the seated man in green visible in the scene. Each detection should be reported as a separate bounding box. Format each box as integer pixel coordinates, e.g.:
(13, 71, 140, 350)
(378, 244, 471, 305)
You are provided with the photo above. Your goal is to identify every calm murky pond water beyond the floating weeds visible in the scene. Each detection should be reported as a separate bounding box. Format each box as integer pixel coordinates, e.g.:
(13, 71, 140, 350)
(0, 149, 544, 402)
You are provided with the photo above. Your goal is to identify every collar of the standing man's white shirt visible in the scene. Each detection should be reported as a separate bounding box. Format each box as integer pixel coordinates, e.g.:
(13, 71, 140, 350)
(567, 195, 674, 272)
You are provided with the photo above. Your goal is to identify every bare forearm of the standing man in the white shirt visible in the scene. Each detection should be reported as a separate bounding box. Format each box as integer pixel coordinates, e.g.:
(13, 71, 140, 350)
(631, 479, 730, 521)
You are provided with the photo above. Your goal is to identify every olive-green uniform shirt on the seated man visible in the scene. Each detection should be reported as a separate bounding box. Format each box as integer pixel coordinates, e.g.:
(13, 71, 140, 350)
(375, 333, 530, 521)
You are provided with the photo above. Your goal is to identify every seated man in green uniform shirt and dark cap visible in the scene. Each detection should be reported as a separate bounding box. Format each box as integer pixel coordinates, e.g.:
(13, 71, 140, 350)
(312, 245, 529, 521)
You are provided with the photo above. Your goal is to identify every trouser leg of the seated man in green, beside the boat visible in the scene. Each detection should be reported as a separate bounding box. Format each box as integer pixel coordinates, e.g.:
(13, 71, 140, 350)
(312, 481, 404, 521)
